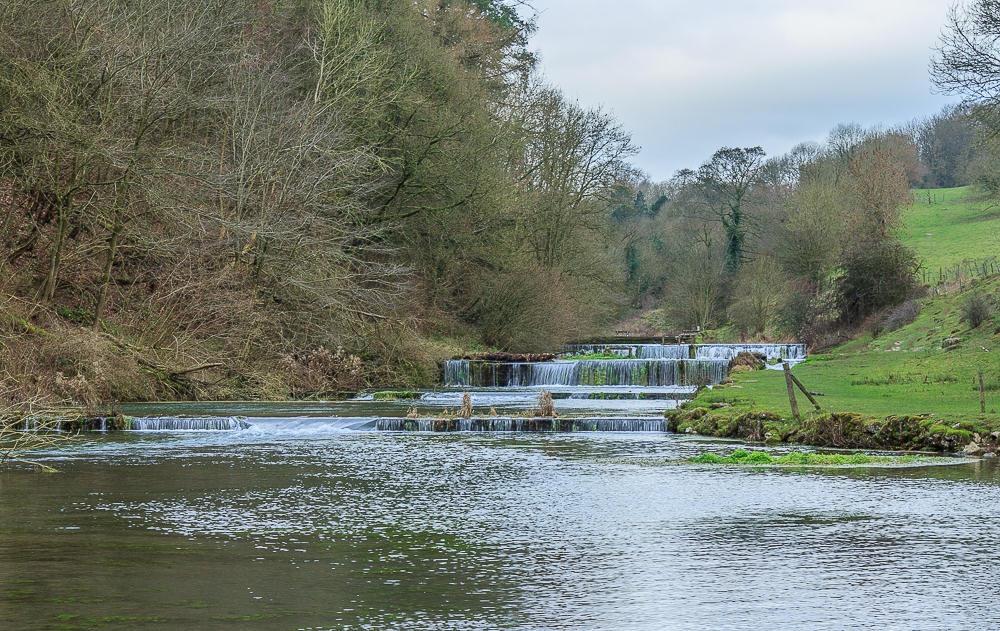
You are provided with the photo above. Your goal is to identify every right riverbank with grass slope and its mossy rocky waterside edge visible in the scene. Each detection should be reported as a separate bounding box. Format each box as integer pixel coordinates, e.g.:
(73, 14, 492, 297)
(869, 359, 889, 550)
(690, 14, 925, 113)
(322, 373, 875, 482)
(667, 278, 1000, 453)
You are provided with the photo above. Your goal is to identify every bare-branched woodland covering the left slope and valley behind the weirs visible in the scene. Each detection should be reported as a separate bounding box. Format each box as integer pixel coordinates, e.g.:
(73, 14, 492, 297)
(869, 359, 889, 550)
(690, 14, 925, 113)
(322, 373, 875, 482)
(0, 0, 1000, 407)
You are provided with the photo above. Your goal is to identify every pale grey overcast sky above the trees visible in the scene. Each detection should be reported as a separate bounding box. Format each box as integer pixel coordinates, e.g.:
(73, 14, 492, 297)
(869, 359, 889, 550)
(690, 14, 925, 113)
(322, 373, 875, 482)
(532, 0, 956, 180)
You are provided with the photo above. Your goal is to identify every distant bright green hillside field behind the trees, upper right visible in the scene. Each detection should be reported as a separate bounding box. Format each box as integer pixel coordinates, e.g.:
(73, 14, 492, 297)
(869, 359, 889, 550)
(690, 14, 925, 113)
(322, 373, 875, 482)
(900, 186, 1000, 275)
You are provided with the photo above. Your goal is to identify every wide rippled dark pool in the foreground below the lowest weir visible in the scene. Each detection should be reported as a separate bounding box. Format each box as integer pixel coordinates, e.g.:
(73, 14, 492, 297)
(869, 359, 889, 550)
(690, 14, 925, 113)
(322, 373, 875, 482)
(0, 419, 1000, 630)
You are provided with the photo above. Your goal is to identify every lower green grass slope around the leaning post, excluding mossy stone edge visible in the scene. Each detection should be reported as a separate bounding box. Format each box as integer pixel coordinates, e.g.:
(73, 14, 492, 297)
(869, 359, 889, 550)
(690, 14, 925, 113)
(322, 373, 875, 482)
(699, 279, 1000, 426)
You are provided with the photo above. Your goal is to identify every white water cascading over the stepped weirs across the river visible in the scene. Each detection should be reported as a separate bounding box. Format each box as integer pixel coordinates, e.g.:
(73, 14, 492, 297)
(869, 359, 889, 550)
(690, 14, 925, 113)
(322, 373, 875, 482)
(111, 343, 806, 434)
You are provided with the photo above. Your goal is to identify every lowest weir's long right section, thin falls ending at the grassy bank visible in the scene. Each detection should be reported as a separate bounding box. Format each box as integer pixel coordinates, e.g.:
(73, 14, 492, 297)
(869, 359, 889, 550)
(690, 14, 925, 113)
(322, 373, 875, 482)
(375, 416, 669, 432)
